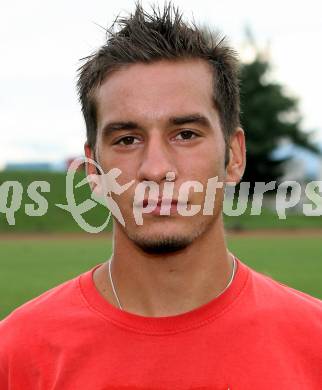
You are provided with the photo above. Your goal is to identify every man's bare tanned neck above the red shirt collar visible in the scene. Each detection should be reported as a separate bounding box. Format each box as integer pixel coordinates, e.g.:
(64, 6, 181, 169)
(94, 215, 233, 317)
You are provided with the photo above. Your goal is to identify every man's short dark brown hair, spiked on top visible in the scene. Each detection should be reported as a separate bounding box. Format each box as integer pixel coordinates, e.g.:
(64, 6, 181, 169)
(77, 3, 240, 164)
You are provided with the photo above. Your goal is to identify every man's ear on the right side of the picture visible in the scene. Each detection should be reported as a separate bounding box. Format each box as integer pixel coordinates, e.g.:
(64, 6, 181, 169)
(225, 127, 246, 184)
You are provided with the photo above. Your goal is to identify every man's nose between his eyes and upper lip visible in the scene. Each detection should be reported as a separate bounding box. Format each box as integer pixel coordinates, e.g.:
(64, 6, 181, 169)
(138, 131, 177, 184)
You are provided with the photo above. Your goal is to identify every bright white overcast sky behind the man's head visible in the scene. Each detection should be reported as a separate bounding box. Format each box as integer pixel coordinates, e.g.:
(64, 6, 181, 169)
(0, 0, 322, 167)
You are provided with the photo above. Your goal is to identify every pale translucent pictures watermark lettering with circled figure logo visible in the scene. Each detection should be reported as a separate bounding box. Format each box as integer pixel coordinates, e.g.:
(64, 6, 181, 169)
(0, 158, 322, 233)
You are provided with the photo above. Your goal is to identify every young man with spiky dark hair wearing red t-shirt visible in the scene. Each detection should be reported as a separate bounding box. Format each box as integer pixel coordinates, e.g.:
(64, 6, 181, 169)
(0, 6, 322, 390)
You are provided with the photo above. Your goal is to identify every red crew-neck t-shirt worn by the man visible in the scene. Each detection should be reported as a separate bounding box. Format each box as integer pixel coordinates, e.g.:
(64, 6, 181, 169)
(0, 260, 322, 390)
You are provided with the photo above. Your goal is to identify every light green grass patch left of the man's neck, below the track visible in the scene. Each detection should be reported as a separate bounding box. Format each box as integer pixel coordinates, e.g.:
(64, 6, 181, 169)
(0, 238, 111, 318)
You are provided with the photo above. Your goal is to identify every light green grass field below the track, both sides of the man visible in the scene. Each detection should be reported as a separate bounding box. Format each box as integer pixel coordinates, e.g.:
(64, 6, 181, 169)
(0, 235, 322, 318)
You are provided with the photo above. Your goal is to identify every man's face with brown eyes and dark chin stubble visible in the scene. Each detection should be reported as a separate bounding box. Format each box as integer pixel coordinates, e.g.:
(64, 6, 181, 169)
(90, 60, 234, 252)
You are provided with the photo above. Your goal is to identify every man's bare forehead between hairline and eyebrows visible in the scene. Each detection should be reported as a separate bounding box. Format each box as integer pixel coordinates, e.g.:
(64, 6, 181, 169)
(94, 60, 214, 122)
